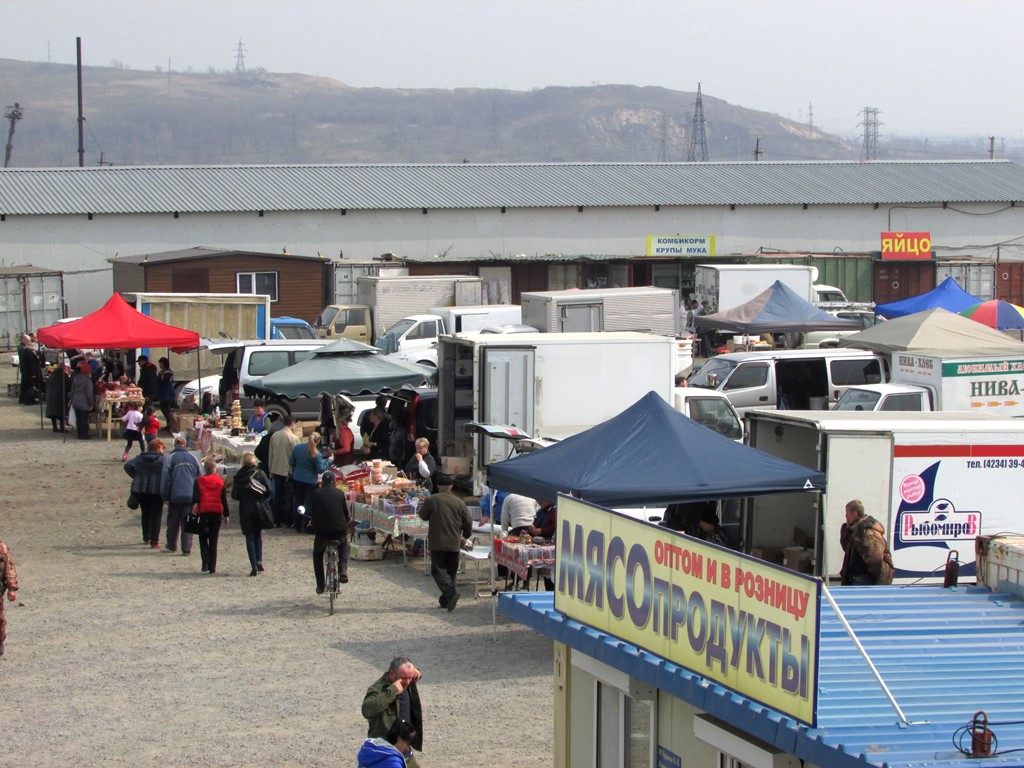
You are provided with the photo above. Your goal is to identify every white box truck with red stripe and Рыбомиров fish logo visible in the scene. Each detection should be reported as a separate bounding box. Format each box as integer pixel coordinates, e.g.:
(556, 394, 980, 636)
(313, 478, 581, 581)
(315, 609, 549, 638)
(737, 411, 1024, 583)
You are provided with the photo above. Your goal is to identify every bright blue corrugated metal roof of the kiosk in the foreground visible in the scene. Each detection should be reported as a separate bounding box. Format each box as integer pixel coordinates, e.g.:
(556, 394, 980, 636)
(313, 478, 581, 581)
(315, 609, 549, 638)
(499, 587, 1024, 768)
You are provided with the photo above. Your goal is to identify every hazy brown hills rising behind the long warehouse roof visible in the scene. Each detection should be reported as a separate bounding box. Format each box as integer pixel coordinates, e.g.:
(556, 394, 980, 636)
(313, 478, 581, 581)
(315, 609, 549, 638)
(0, 58, 1007, 168)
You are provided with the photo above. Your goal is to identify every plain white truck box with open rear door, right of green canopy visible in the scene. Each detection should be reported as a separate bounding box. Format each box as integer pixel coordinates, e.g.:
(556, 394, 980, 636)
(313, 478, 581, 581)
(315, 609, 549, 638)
(437, 332, 675, 494)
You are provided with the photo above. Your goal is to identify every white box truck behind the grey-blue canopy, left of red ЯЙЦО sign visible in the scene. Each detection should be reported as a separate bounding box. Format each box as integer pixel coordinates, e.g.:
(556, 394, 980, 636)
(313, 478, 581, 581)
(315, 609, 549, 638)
(693, 264, 818, 313)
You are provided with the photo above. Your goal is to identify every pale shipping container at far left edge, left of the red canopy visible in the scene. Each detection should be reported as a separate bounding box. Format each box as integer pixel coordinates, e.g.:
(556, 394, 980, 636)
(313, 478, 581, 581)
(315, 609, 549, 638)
(0, 265, 66, 349)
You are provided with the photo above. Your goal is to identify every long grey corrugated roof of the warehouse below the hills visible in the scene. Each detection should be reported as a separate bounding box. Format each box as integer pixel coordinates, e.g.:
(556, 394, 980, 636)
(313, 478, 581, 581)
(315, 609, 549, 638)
(0, 161, 1024, 215)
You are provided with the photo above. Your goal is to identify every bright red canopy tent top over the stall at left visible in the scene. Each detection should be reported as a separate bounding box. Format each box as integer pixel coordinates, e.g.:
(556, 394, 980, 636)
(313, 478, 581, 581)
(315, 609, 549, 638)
(36, 293, 199, 352)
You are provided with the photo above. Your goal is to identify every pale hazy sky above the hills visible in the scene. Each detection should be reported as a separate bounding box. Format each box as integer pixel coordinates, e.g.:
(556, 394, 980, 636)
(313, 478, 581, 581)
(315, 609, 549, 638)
(0, 0, 1024, 139)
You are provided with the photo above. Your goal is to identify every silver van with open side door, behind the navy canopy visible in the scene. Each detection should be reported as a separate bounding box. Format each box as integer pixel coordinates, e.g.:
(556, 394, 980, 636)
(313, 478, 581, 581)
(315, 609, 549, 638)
(689, 349, 890, 416)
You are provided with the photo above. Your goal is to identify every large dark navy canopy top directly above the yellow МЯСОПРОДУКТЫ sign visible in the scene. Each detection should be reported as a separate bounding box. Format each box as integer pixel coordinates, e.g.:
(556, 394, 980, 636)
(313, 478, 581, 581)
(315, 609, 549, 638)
(488, 392, 825, 507)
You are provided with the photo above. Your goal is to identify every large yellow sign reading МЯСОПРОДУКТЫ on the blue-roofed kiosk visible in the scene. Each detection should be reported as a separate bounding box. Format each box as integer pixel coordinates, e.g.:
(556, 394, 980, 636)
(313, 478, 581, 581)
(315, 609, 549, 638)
(555, 496, 821, 727)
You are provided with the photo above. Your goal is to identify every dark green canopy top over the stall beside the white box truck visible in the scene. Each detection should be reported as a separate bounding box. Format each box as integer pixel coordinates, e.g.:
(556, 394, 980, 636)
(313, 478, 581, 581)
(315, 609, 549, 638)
(246, 339, 437, 400)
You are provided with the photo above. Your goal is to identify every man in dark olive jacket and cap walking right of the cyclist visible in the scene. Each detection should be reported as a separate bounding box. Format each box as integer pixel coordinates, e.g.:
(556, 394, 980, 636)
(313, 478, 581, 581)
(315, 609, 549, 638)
(420, 473, 473, 612)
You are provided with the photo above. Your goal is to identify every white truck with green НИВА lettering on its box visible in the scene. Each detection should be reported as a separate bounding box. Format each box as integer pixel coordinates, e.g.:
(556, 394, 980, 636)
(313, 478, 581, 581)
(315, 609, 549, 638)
(836, 351, 1024, 417)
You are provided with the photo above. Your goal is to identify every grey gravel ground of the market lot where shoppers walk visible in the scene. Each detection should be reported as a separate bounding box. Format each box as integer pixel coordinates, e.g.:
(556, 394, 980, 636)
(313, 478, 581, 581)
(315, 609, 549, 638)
(0, 367, 553, 768)
